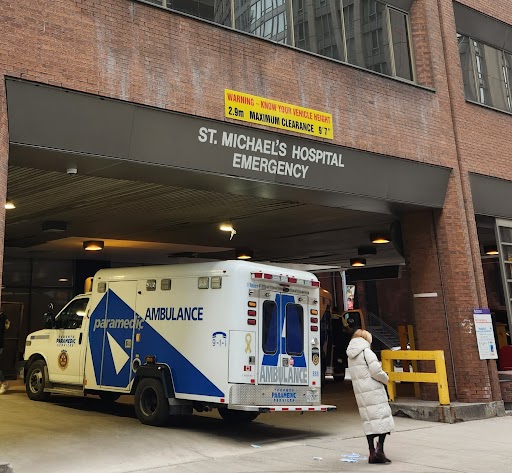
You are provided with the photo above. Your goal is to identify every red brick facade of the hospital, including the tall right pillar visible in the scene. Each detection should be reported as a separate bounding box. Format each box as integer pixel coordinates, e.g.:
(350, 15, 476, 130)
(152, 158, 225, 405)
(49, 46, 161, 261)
(0, 0, 512, 402)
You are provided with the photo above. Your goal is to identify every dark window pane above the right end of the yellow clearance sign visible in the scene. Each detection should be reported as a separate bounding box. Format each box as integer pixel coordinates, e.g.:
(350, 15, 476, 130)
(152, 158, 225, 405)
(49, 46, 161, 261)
(293, 0, 344, 60)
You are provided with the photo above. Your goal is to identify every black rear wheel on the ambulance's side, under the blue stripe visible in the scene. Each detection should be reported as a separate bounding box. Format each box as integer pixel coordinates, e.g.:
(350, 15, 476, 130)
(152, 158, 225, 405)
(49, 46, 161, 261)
(135, 378, 169, 426)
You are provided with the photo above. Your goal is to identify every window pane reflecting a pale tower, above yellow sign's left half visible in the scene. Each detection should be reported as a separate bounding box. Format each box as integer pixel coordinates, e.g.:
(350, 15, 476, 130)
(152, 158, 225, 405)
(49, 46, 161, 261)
(235, 0, 292, 45)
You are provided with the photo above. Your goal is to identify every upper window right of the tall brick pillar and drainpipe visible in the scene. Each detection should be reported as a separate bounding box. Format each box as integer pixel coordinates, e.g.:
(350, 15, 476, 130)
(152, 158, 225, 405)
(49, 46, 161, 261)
(457, 35, 512, 112)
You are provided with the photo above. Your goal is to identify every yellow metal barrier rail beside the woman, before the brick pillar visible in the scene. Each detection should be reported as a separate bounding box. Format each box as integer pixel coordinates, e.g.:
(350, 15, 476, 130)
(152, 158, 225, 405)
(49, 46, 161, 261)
(381, 350, 450, 405)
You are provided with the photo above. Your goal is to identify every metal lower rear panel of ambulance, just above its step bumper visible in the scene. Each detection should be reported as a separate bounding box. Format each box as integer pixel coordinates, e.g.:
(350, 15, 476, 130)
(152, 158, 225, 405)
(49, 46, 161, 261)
(229, 384, 321, 406)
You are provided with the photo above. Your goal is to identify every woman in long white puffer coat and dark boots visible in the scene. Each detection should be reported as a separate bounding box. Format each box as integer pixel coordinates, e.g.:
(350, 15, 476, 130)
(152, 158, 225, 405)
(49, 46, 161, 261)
(347, 329, 395, 463)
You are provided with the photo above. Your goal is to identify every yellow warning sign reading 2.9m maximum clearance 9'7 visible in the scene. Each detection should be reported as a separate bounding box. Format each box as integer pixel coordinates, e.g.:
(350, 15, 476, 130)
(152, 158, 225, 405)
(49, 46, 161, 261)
(224, 89, 334, 140)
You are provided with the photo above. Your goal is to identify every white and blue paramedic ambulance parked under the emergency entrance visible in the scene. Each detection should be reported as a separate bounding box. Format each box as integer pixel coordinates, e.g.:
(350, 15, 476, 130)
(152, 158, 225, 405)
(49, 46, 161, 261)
(23, 261, 336, 425)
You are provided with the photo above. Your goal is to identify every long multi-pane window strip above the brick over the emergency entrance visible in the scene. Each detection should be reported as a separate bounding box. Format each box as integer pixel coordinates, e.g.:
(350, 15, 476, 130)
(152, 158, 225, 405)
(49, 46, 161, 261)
(138, 0, 414, 81)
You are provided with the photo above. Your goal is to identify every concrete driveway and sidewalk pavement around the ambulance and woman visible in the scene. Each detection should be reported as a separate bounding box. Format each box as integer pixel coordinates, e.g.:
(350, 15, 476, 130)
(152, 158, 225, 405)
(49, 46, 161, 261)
(0, 381, 512, 473)
